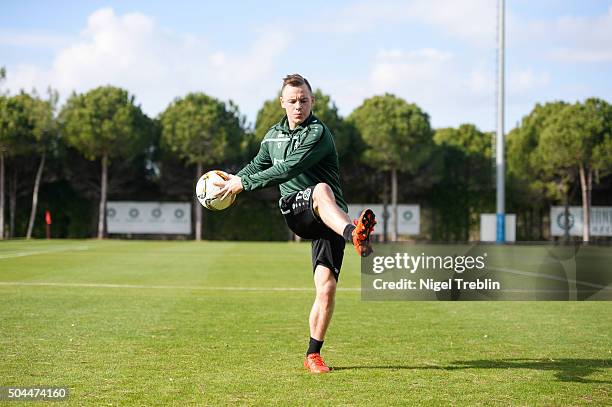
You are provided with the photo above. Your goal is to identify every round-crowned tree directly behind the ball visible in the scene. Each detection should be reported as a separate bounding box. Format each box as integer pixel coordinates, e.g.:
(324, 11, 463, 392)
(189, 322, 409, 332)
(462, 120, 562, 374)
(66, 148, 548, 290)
(160, 93, 244, 240)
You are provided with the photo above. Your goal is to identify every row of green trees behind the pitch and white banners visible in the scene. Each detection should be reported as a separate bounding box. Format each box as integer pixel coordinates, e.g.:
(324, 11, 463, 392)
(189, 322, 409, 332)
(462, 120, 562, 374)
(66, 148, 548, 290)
(0, 78, 612, 241)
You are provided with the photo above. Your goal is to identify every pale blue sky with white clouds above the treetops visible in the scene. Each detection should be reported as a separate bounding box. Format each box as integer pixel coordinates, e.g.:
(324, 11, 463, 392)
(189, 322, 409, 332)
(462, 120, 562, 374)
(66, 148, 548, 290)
(0, 0, 612, 130)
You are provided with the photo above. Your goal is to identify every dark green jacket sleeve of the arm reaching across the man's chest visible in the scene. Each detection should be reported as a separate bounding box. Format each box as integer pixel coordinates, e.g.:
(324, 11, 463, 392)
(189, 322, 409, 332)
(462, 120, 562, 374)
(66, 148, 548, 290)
(242, 125, 330, 191)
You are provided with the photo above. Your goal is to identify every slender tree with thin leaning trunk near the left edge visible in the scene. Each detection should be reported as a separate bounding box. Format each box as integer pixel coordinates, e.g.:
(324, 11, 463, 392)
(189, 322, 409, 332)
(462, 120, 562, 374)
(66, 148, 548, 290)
(26, 89, 58, 239)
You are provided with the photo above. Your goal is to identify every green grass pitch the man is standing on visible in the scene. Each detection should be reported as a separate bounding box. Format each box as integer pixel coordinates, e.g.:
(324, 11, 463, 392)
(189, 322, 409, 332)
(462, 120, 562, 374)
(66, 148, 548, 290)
(0, 241, 612, 406)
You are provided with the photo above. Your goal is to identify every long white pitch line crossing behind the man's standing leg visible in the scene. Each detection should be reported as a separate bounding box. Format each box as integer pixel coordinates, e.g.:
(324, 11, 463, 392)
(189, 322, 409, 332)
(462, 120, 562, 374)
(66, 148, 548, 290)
(0, 281, 360, 292)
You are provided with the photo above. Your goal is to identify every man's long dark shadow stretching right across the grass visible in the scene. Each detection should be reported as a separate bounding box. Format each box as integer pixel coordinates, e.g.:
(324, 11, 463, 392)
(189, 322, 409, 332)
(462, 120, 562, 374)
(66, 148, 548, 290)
(333, 359, 612, 384)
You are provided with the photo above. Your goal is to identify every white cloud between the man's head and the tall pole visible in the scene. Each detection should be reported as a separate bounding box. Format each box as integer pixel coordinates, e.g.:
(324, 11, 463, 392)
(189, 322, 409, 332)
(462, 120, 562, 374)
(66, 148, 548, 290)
(321, 44, 495, 130)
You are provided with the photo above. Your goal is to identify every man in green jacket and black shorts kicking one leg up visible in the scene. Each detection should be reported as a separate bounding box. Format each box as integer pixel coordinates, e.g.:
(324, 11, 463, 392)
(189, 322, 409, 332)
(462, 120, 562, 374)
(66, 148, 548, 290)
(216, 74, 376, 373)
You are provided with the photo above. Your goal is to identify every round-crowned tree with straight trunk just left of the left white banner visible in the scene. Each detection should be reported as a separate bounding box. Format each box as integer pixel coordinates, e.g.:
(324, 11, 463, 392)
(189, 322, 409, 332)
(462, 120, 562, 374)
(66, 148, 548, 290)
(59, 86, 151, 239)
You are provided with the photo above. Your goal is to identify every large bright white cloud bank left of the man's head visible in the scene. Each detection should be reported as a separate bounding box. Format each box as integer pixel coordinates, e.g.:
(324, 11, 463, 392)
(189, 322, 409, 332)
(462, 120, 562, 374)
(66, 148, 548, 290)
(6, 8, 291, 120)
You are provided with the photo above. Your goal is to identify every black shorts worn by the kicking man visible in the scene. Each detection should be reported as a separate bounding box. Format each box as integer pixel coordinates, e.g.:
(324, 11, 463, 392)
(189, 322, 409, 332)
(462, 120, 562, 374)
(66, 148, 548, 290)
(280, 186, 345, 281)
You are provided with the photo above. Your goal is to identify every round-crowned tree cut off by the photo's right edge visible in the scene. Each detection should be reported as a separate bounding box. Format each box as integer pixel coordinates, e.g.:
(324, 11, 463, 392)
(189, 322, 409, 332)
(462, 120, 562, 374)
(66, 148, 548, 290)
(537, 98, 612, 242)
